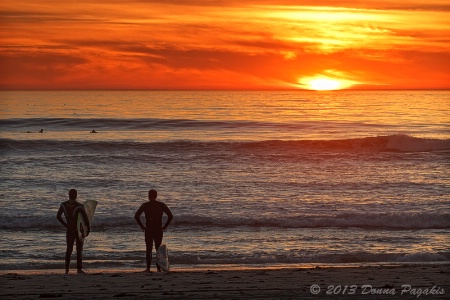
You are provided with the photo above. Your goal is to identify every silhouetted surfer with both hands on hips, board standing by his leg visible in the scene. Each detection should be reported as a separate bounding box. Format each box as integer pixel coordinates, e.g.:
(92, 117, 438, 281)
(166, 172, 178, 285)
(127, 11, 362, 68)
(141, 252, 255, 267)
(134, 190, 173, 273)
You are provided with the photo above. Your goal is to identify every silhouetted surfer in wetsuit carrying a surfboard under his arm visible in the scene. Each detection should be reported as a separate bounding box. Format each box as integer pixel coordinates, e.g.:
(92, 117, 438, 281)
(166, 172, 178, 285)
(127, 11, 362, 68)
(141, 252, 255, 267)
(56, 189, 90, 274)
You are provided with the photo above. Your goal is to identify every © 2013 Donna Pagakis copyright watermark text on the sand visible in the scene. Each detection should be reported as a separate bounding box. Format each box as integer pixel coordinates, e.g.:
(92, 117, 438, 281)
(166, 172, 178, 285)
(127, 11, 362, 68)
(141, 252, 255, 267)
(309, 284, 445, 298)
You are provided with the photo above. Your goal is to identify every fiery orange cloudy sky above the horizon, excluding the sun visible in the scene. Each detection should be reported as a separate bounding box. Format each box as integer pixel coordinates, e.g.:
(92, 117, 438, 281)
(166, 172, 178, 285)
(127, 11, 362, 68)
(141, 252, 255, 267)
(0, 0, 450, 90)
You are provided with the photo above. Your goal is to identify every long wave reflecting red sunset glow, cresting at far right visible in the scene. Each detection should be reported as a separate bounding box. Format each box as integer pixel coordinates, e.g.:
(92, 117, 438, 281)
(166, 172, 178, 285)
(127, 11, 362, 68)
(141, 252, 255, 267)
(0, 135, 450, 153)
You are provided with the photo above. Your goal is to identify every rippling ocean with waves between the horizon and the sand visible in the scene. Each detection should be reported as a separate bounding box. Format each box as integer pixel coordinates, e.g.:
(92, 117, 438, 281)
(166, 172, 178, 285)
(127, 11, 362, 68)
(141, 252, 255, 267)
(0, 91, 450, 270)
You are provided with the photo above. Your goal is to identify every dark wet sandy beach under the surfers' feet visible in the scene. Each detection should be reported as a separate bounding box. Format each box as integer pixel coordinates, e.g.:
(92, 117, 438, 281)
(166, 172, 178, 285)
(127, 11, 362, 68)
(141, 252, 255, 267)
(0, 264, 450, 299)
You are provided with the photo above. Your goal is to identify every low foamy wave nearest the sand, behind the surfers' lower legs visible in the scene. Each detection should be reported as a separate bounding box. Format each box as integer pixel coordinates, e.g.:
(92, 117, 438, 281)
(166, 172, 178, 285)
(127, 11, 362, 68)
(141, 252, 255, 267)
(0, 251, 450, 270)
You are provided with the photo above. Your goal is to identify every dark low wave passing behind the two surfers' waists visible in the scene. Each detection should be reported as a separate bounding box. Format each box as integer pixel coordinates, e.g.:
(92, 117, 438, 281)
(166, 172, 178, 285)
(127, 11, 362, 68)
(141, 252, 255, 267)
(0, 213, 450, 231)
